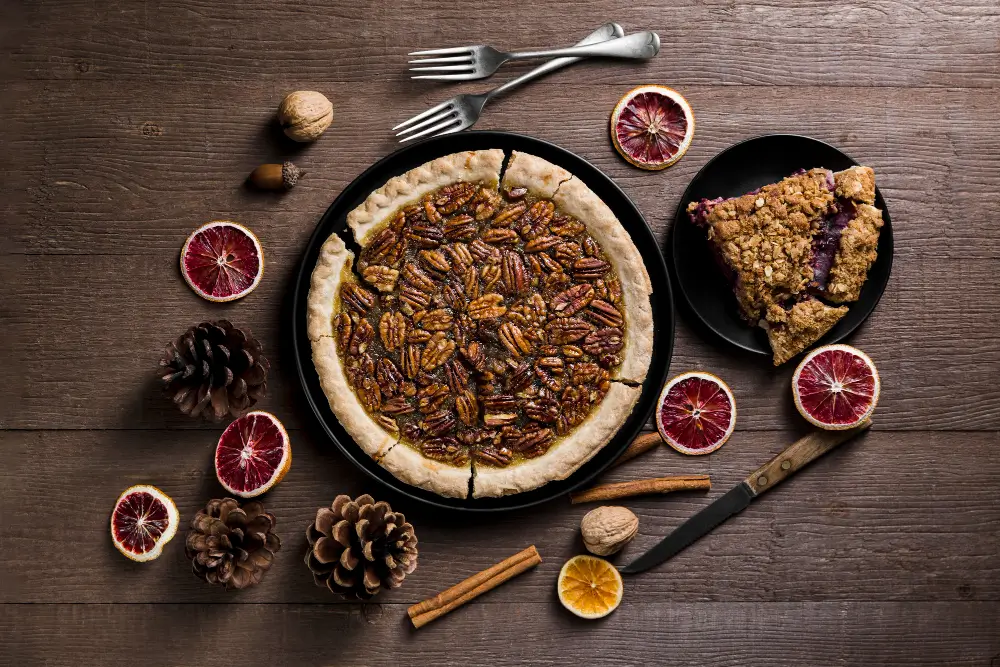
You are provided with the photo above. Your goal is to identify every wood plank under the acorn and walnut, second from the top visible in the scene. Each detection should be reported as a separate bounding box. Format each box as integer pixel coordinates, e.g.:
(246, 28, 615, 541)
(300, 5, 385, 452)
(0, 82, 1000, 260)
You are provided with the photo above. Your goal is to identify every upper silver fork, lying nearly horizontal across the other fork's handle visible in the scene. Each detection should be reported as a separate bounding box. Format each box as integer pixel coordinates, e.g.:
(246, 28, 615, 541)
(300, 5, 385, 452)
(409, 30, 660, 81)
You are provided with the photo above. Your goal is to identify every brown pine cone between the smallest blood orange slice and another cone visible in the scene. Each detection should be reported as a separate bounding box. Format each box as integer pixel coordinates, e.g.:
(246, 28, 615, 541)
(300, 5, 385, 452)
(184, 498, 281, 589)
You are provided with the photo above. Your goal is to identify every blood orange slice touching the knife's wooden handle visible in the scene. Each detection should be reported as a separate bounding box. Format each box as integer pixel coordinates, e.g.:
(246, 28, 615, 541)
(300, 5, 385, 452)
(792, 345, 882, 431)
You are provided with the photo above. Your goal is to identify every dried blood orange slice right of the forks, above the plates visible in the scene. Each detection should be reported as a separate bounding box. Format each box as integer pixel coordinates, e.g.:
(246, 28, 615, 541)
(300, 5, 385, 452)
(611, 86, 694, 170)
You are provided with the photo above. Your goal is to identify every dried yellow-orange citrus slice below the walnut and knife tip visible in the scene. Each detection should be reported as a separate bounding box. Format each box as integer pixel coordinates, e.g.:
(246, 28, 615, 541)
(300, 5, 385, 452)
(556, 555, 625, 618)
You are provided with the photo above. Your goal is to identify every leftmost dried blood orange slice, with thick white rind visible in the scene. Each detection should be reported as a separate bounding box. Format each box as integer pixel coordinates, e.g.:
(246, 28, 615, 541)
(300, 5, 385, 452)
(111, 484, 180, 563)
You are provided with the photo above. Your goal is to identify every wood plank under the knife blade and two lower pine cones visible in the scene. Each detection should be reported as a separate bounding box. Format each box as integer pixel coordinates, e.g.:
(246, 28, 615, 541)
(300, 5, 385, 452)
(0, 425, 1000, 606)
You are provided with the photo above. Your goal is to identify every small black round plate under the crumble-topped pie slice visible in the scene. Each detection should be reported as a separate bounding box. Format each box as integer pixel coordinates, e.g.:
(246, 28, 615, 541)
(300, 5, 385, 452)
(670, 134, 893, 356)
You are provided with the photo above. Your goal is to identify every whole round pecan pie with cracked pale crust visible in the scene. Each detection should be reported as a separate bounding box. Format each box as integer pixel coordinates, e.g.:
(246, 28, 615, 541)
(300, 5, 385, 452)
(308, 150, 653, 497)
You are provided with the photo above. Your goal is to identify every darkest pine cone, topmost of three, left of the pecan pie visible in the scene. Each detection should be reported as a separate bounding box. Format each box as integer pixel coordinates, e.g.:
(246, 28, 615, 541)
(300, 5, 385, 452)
(160, 320, 271, 421)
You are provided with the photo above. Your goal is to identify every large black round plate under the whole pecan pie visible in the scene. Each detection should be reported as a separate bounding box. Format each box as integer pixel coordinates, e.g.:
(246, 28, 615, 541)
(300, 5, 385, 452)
(292, 132, 674, 512)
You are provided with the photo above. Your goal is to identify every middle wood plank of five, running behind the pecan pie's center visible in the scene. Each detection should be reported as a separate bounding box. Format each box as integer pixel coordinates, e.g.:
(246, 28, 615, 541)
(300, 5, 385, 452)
(0, 249, 1000, 430)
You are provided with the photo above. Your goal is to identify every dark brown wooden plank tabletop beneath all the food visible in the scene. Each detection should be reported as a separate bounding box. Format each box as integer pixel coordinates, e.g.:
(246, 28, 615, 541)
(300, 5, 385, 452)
(0, 0, 1000, 667)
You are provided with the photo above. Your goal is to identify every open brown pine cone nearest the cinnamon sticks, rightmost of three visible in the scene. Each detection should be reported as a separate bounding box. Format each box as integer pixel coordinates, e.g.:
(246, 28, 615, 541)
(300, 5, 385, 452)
(306, 494, 417, 600)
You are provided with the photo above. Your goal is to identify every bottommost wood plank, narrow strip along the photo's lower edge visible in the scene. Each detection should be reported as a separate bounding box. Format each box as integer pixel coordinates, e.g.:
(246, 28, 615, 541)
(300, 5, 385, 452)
(0, 600, 1000, 667)
